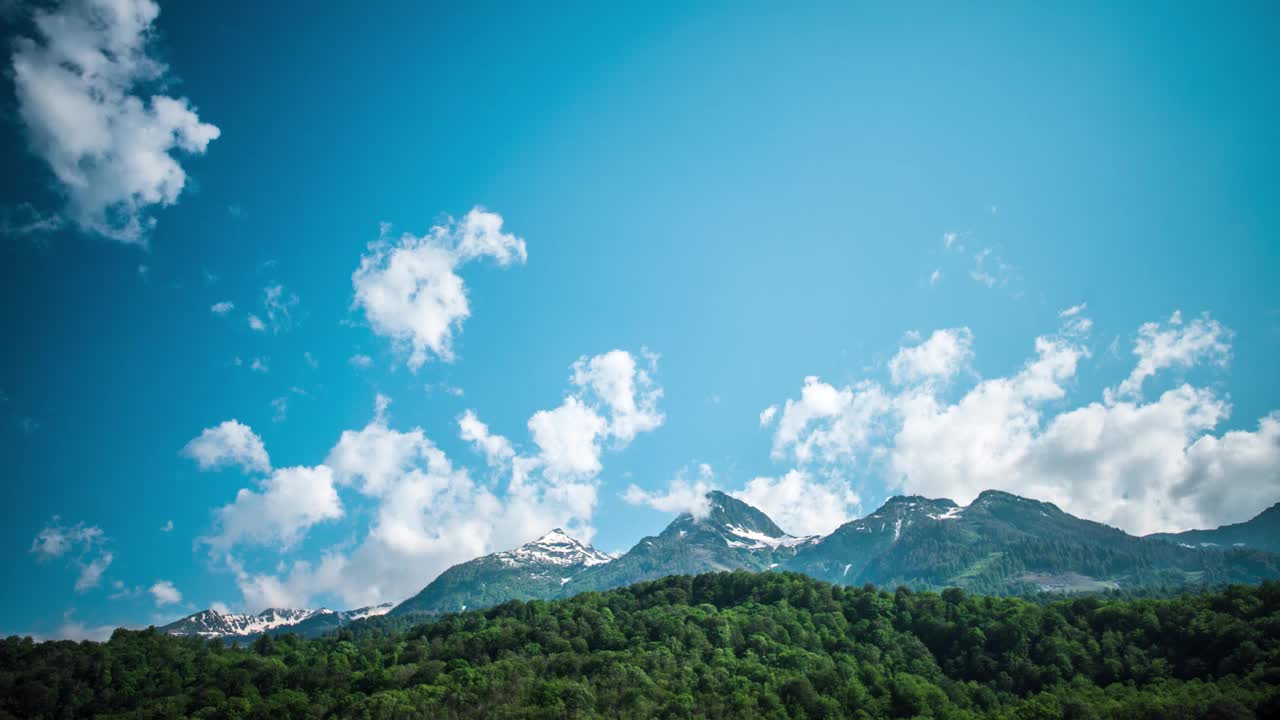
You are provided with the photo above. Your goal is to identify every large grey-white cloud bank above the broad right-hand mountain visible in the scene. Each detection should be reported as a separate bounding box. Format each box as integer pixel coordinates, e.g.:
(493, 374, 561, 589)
(774, 306, 1280, 533)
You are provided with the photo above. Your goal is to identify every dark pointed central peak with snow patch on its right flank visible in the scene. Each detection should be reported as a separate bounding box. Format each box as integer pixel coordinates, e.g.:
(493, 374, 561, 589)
(559, 491, 817, 596)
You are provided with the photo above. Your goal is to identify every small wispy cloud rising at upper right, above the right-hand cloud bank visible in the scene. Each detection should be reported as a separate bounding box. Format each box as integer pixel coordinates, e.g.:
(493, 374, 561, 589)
(1119, 311, 1231, 397)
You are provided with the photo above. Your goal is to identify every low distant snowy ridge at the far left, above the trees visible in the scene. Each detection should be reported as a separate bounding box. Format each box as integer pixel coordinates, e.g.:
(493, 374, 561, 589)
(159, 603, 392, 639)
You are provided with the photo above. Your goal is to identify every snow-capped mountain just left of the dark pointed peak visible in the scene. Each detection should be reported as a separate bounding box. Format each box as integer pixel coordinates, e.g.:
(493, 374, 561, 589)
(392, 528, 612, 615)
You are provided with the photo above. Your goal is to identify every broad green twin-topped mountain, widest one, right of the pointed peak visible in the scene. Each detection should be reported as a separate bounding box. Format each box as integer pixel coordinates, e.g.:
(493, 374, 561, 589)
(786, 491, 1280, 594)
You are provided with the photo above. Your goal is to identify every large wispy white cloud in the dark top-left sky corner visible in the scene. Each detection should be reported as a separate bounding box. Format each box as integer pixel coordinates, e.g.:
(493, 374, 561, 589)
(13, 0, 219, 243)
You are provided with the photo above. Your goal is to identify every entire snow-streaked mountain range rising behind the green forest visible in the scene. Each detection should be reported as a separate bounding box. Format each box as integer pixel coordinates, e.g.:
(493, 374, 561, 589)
(161, 491, 1280, 639)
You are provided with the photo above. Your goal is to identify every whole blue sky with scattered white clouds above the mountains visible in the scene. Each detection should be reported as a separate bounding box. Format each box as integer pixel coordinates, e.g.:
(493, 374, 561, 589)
(0, 0, 1280, 638)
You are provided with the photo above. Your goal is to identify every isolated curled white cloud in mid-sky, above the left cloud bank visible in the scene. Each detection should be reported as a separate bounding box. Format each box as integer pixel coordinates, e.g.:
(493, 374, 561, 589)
(351, 208, 527, 370)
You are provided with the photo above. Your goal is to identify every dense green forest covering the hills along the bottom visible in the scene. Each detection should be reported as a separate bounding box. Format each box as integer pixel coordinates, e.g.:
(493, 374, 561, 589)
(0, 571, 1280, 719)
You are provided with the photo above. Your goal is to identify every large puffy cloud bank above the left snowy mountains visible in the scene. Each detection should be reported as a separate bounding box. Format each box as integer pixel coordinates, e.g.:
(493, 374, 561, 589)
(205, 351, 662, 609)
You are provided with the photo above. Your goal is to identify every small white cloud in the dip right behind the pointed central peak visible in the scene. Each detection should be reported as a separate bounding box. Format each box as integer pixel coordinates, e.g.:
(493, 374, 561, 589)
(730, 470, 861, 536)
